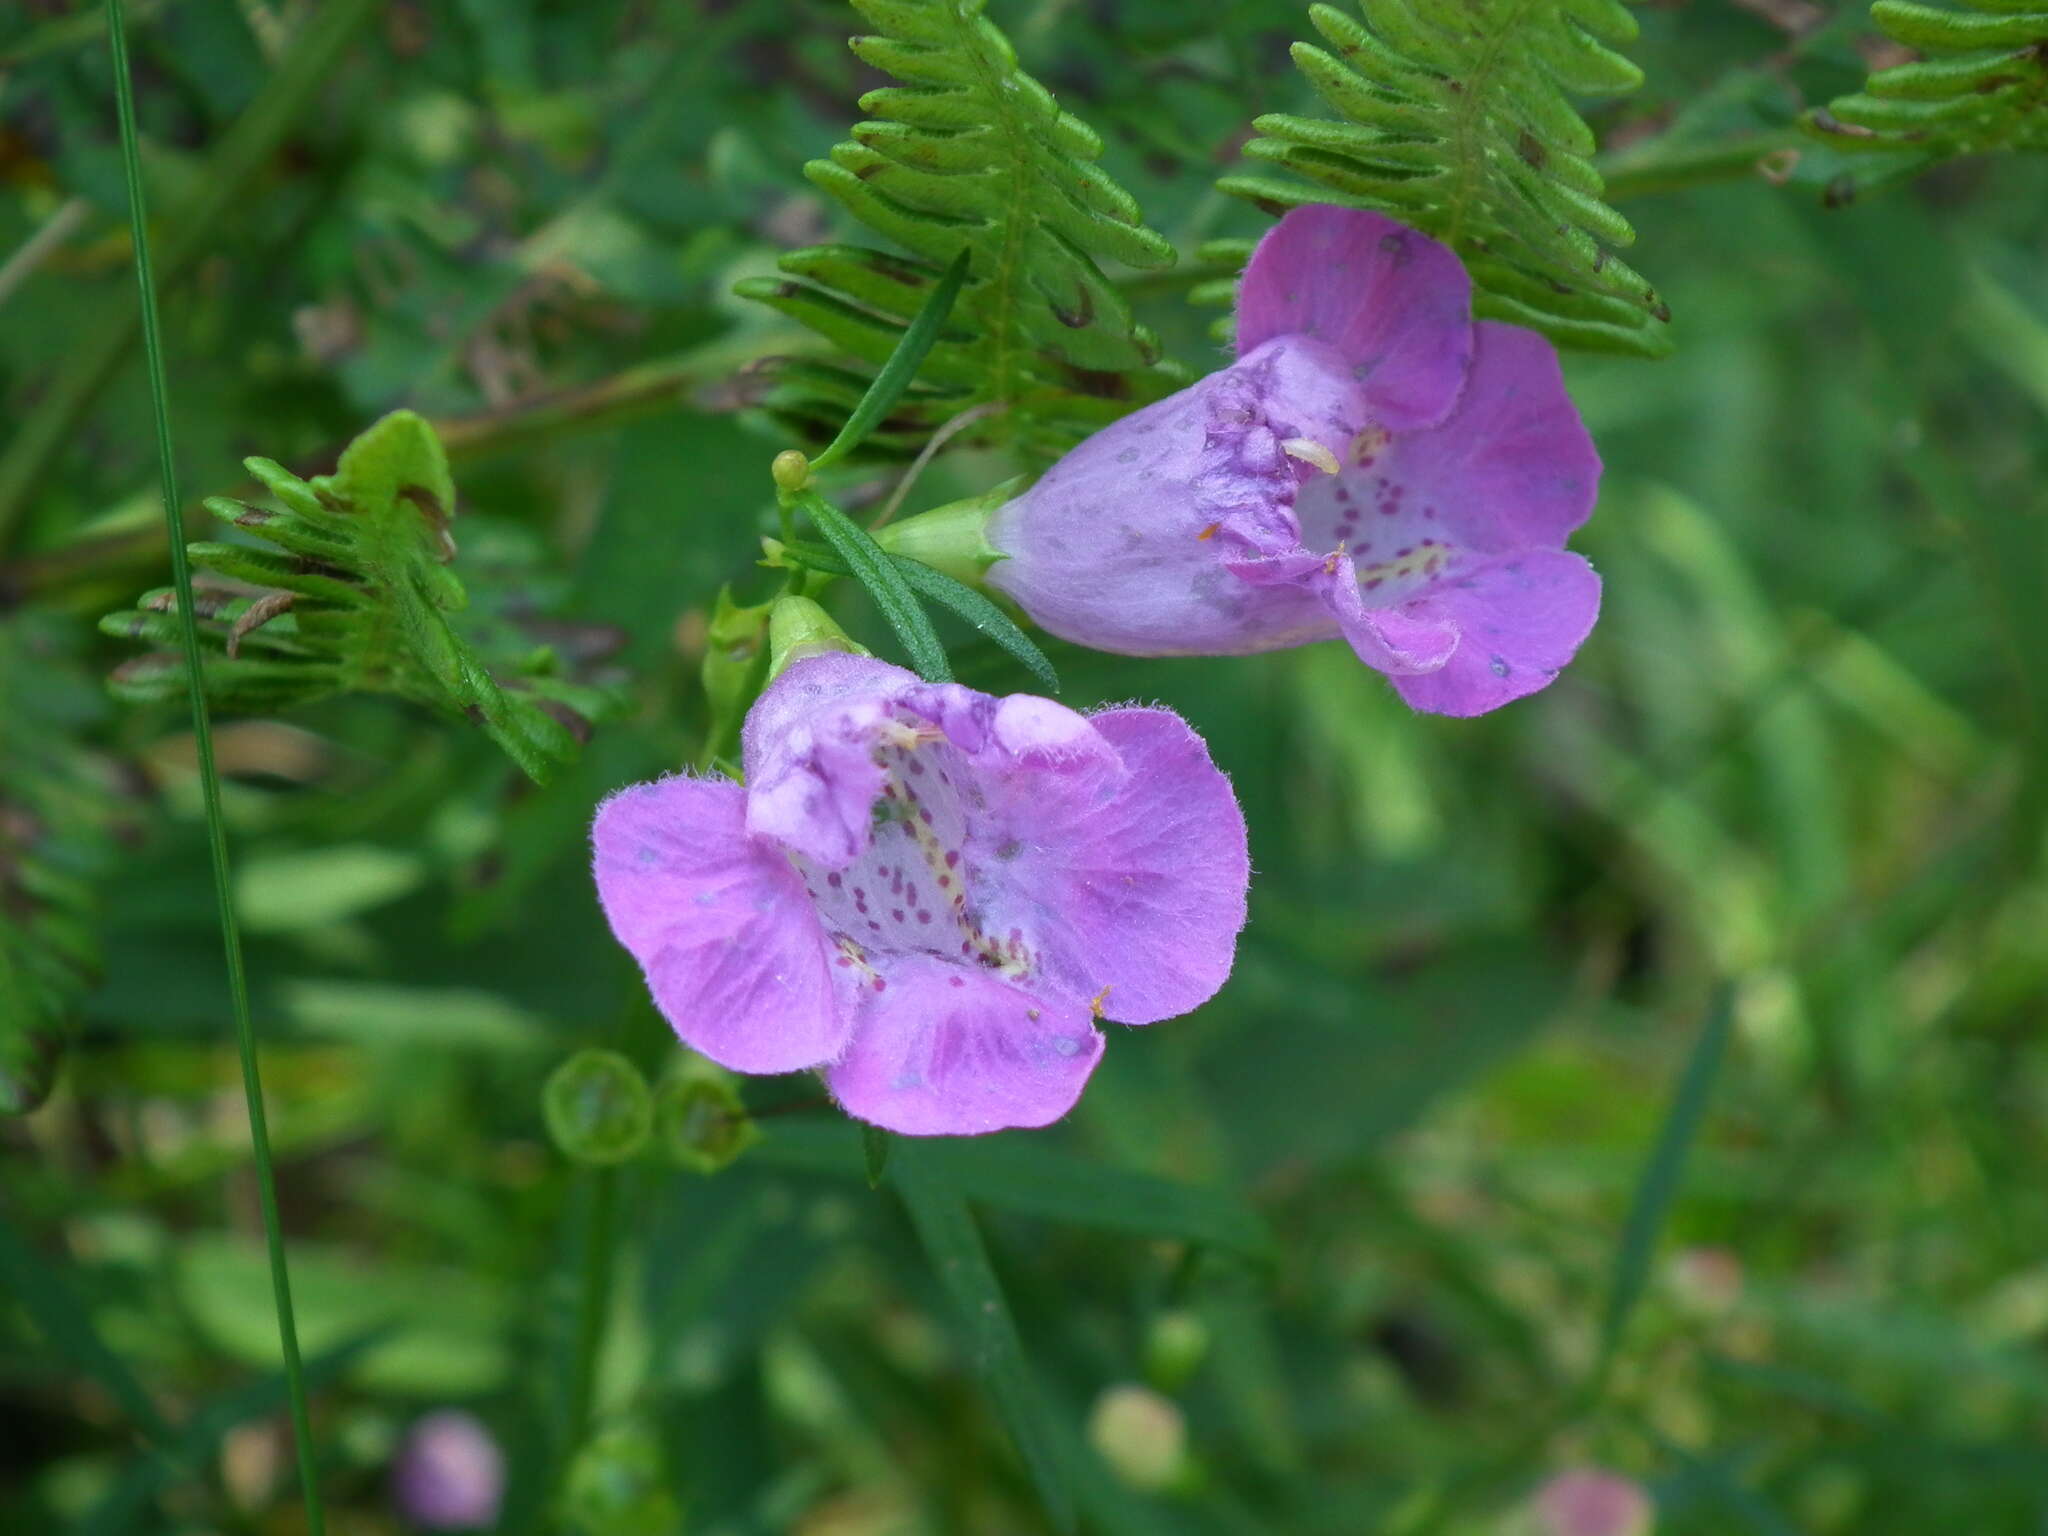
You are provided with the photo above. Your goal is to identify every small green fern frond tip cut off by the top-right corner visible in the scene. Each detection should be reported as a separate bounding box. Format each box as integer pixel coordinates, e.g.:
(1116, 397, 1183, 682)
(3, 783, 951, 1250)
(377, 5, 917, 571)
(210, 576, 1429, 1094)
(1804, 0, 2048, 170)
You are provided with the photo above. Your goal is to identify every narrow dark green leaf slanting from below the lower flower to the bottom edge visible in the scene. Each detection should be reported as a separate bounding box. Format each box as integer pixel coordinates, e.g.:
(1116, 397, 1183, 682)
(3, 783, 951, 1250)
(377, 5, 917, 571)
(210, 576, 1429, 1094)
(895, 1147, 1073, 1532)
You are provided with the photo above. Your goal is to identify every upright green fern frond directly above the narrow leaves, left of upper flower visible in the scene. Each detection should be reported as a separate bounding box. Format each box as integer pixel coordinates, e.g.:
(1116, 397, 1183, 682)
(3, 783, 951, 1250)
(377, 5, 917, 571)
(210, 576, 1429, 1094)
(739, 0, 1186, 459)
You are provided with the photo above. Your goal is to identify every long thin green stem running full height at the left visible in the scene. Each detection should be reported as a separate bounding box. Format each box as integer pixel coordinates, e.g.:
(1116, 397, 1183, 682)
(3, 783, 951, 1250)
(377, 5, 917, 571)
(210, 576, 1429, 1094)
(106, 0, 326, 1536)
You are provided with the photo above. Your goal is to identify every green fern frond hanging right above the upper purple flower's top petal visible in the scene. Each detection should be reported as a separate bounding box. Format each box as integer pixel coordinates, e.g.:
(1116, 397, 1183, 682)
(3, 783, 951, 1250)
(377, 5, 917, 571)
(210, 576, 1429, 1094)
(1221, 0, 1671, 356)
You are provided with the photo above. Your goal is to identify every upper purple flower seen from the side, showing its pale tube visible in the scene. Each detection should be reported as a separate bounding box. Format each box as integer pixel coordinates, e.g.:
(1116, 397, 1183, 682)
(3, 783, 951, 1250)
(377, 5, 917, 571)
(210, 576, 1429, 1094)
(987, 207, 1599, 715)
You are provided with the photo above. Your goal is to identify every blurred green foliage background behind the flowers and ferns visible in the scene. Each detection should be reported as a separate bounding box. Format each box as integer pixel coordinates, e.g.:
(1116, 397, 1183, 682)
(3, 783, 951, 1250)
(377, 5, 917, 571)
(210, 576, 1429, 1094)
(0, 0, 2048, 1536)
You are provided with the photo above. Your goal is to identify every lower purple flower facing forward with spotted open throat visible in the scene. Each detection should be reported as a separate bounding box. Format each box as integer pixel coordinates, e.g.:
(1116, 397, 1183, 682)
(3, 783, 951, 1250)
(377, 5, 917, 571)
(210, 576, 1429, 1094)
(594, 653, 1249, 1135)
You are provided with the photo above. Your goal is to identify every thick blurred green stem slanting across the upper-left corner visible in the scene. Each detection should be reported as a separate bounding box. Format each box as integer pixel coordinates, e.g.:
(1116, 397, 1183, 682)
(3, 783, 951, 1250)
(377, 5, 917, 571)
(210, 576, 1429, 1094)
(0, 0, 383, 549)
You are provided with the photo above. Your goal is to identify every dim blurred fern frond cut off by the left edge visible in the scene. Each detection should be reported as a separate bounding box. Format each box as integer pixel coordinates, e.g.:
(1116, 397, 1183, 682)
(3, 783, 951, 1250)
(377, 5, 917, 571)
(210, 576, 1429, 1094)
(0, 612, 133, 1114)
